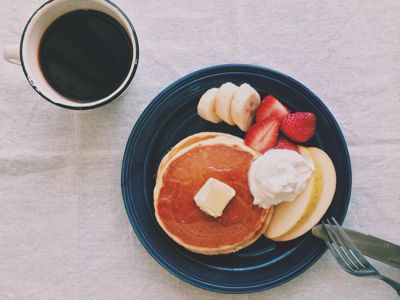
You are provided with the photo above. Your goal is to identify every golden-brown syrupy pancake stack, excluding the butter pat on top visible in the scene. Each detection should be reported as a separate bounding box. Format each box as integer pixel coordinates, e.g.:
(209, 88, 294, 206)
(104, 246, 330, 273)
(154, 132, 272, 255)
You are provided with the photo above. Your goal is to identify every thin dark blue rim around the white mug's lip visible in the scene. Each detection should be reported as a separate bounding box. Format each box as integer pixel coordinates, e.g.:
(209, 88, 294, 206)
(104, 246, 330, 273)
(19, 0, 139, 110)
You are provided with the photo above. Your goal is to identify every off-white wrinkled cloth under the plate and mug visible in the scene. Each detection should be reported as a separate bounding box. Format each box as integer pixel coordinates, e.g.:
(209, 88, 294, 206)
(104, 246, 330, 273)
(0, 0, 400, 299)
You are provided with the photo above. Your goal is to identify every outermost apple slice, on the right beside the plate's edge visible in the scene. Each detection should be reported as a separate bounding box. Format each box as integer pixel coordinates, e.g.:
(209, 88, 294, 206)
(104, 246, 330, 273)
(275, 147, 336, 241)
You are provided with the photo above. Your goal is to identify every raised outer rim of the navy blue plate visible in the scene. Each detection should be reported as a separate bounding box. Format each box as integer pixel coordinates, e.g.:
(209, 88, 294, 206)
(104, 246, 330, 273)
(121, 64, 352, 294)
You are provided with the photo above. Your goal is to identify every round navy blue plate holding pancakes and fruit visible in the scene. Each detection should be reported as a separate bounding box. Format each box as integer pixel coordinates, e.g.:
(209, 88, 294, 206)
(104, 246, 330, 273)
(121, 65, 351, 293)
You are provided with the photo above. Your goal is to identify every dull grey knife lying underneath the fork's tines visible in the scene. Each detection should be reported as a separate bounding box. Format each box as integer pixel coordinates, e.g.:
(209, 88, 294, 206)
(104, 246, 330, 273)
(312, 225, 400, 269)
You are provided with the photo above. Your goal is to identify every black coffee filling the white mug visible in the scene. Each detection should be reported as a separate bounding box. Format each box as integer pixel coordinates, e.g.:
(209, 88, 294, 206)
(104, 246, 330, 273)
(39, 10, 133, 102)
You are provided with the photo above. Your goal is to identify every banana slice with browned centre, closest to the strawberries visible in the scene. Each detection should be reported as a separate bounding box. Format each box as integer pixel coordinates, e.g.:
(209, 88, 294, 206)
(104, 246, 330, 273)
(231, 83, 260, 131)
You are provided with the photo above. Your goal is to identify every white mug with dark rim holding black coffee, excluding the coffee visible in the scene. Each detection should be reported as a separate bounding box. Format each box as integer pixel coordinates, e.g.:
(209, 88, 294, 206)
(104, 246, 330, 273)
(3, 0, 139, 109)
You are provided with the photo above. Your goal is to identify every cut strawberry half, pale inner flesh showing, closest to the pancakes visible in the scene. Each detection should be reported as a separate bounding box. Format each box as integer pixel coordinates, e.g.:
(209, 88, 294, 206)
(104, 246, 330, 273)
(244, 116, 280, 153)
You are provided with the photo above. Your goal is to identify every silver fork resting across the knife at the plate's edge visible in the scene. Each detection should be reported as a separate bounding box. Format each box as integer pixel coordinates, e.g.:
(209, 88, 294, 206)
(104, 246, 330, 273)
(322, 218, 400, 295)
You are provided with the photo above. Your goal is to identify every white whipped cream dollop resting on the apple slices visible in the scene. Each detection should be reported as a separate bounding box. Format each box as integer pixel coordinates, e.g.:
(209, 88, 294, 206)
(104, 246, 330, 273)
(248, 149, 314, 208)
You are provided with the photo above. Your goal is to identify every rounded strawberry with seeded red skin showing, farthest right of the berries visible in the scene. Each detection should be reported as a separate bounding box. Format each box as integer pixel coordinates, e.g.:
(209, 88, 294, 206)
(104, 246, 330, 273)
(281, 112, 316, 143)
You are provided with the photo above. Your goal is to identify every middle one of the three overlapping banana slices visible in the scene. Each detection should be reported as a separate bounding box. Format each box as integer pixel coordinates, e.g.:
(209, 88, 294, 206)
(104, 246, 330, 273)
(215, 82, 238, 125)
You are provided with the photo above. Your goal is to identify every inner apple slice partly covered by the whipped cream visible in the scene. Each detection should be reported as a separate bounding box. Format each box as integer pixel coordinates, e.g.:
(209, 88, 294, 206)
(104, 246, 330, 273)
(264, 147, 316, 240)
